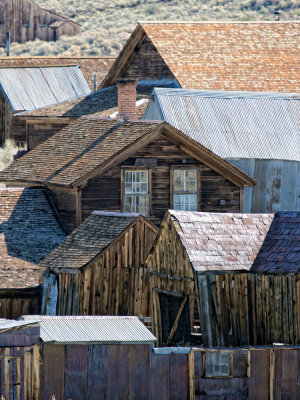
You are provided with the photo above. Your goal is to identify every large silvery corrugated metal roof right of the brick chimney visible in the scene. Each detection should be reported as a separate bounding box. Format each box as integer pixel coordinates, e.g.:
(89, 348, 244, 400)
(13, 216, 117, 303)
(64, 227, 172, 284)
(149, 88, 300, 161)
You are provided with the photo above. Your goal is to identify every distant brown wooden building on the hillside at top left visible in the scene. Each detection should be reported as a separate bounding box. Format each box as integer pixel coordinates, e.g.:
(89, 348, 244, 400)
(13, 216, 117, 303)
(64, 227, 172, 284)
(0, 0, 80, 46)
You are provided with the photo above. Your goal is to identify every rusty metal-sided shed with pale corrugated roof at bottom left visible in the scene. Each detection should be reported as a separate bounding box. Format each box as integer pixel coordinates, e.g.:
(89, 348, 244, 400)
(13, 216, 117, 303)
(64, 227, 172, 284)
(22, 315, 156, 400)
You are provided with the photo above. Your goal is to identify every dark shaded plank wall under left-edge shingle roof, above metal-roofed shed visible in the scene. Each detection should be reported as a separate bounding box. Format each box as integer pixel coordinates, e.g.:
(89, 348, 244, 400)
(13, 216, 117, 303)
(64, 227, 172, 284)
(0, 288, 41, 319)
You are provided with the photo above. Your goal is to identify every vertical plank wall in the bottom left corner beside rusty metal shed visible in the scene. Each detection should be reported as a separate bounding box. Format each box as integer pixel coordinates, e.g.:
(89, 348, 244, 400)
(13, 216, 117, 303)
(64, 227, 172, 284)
(0, 345, 40, 400)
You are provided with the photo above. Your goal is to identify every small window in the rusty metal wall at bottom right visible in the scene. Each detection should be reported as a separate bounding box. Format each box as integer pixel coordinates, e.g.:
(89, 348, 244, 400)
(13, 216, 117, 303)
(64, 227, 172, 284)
(205, 351, 231, 377)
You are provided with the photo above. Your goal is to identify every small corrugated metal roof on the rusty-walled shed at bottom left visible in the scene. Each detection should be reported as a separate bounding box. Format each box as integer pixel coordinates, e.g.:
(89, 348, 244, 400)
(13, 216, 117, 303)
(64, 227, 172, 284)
(20, 315, 156, 343)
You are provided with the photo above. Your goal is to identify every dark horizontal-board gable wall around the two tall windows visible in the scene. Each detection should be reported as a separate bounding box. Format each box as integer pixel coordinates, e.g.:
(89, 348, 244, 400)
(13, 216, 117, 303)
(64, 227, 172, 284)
(82, 137, 240, 224)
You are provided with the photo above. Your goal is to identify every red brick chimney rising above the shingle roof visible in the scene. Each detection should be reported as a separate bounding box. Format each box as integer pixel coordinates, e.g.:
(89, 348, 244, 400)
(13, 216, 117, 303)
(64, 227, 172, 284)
(116, 79, 137, 119)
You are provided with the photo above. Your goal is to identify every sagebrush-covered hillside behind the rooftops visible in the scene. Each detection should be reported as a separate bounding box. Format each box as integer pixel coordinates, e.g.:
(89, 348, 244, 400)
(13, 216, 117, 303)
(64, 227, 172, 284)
(0, 0, 300, 56)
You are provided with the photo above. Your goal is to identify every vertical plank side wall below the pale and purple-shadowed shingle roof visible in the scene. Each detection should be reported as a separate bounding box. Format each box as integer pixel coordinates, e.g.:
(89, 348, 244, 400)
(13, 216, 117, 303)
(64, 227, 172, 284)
(198, 272, 300, 346)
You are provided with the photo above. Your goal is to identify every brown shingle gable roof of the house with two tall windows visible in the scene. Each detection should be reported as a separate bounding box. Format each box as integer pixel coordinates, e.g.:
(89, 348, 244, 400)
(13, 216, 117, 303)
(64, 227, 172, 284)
(0, 116, 256, 188)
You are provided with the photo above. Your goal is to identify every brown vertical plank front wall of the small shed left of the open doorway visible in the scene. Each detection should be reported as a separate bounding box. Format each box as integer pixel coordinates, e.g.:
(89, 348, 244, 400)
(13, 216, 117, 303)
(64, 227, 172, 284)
(58, 220, 156, 316)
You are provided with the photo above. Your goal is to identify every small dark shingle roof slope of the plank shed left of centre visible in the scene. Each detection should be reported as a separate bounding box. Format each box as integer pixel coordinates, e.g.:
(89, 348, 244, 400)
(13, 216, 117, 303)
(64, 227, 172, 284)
(41, 211, 139, 268)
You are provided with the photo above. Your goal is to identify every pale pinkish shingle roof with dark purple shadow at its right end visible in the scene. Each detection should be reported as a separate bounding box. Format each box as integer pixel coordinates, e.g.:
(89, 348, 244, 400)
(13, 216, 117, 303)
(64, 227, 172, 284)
(169, 210, 300, 273)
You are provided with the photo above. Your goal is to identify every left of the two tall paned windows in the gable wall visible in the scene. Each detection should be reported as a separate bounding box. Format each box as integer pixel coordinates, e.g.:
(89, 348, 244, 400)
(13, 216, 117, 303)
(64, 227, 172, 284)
(123, 170, 149, 215)
